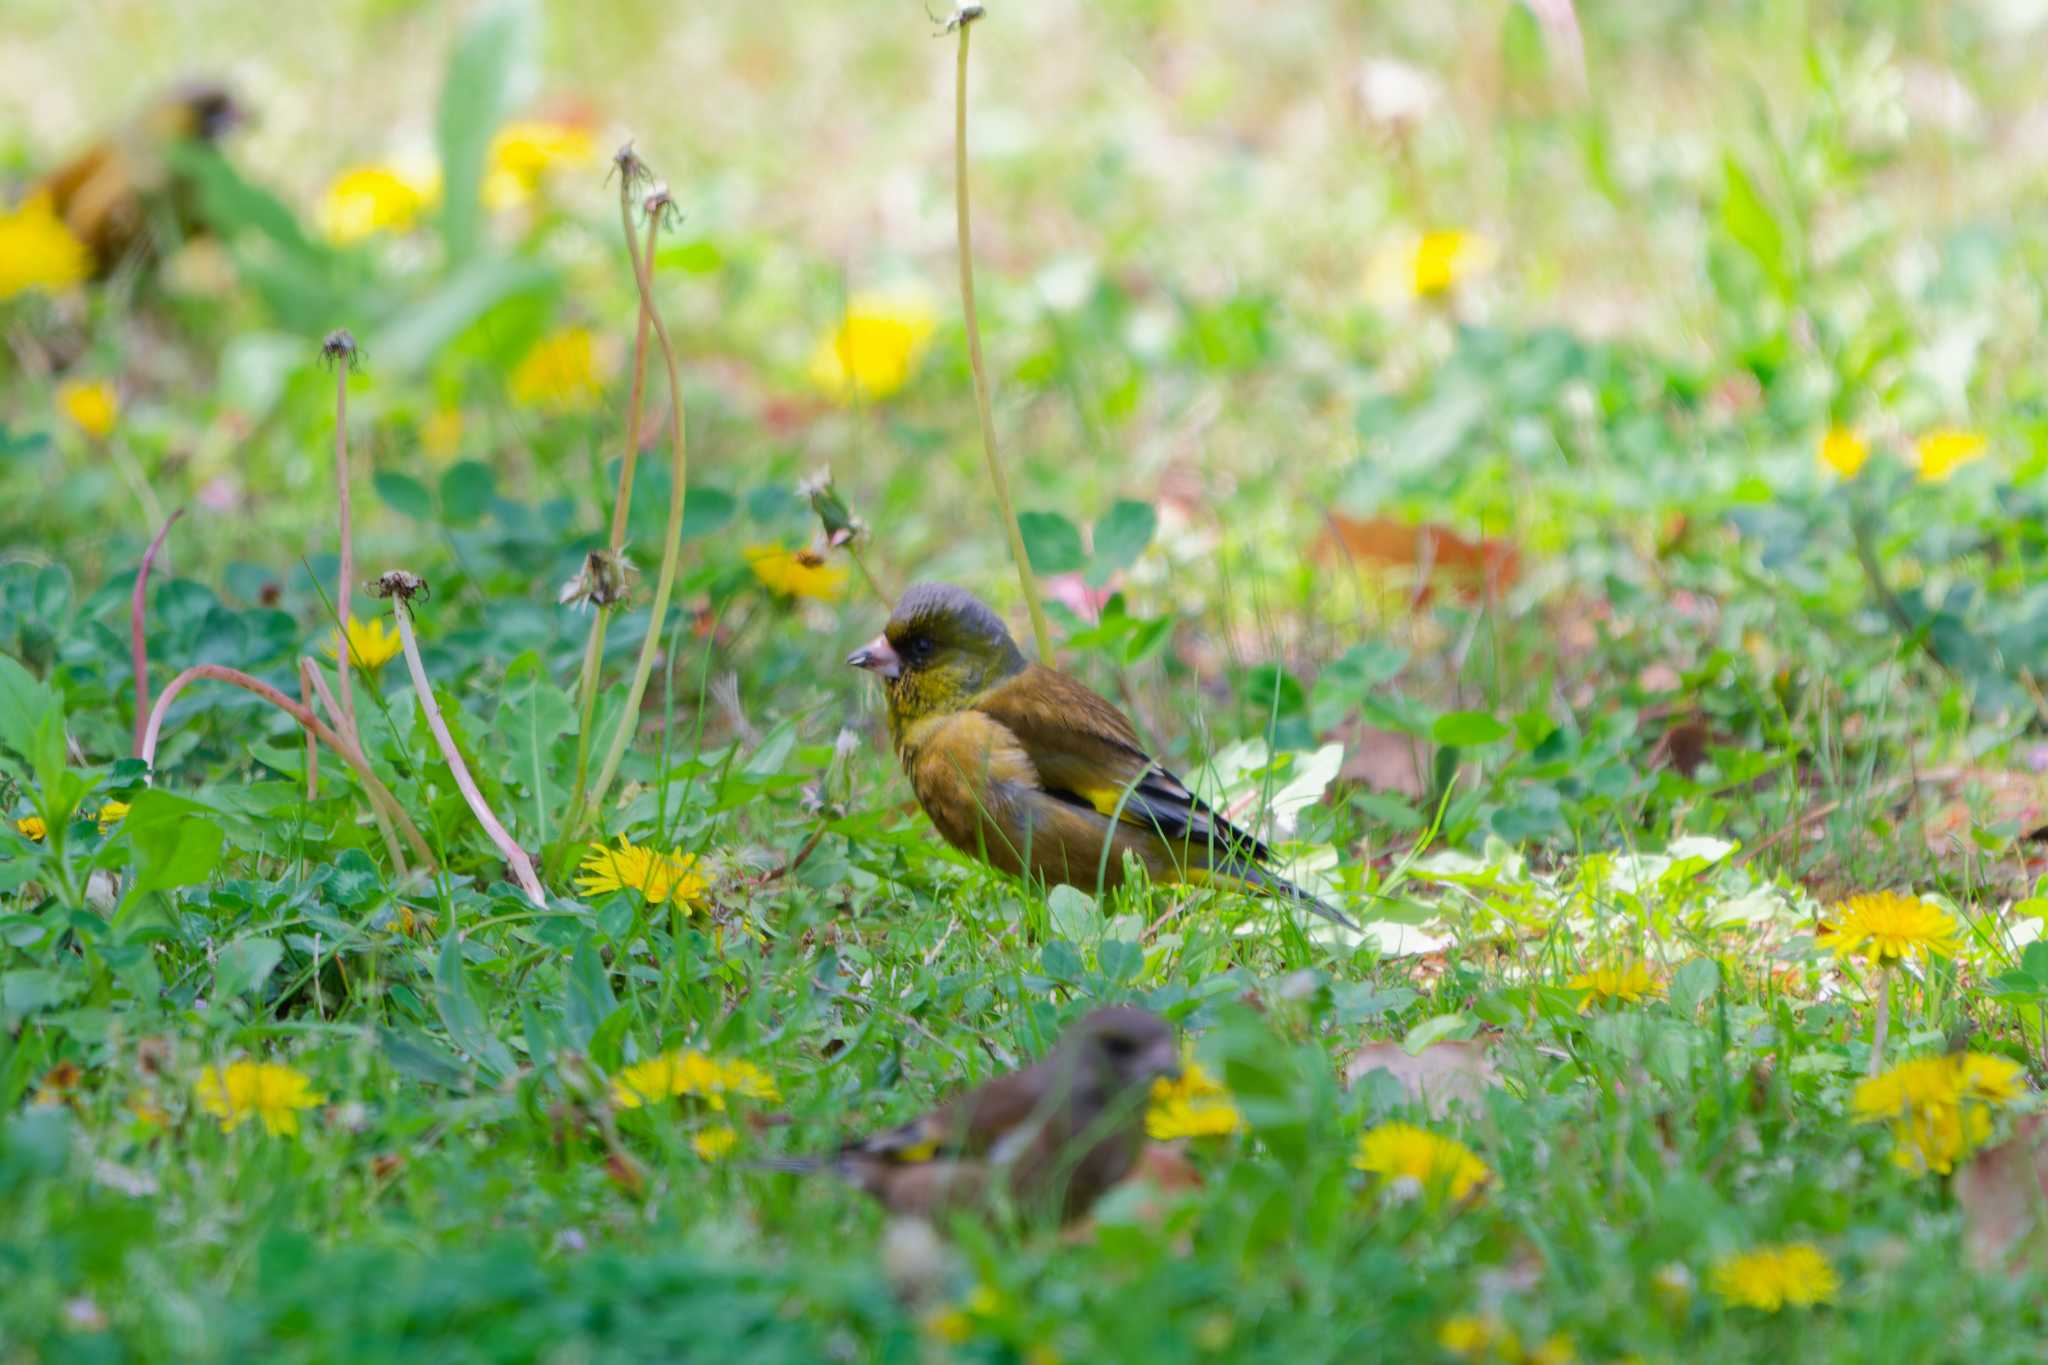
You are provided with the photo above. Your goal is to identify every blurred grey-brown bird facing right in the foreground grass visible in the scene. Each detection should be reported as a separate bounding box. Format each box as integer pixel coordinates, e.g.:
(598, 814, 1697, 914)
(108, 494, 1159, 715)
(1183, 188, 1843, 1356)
(766, 1005, 1180, 1222)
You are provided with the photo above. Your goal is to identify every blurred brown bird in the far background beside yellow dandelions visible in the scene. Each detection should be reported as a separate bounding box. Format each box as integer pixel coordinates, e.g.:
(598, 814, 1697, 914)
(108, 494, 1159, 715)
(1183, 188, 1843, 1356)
(29, 82, 244, 278)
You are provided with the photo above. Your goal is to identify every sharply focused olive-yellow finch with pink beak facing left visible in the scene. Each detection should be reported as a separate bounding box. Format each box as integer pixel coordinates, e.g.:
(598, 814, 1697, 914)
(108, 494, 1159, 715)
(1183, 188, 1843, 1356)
(846, 583, 1356, 929)
